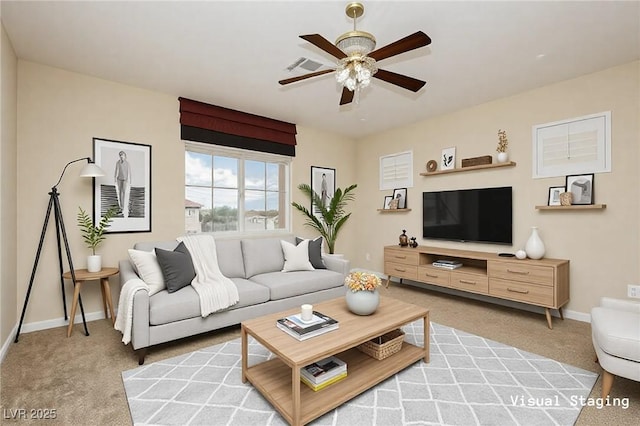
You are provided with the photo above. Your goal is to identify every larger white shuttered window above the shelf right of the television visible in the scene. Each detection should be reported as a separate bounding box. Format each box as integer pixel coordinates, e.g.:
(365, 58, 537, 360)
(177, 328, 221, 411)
(532, 111, 611, 179)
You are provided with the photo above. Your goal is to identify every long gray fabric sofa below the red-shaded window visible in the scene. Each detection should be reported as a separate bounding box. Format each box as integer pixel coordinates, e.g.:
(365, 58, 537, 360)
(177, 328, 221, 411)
(119, 236, 349, 364)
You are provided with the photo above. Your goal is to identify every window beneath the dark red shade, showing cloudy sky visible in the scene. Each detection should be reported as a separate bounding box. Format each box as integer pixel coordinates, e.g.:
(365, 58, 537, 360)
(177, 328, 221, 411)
(185, 142, 291, 234)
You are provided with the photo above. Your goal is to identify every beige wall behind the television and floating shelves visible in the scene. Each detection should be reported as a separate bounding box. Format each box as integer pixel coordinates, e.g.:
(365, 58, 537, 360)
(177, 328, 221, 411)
(353, 62, 640, 313)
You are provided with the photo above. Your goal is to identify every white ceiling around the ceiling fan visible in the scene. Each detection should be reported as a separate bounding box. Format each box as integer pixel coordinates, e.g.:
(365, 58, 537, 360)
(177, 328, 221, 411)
(1, 0, 640, 137)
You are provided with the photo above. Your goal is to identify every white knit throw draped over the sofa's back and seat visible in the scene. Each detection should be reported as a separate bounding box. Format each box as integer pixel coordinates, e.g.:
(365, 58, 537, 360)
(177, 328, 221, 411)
(178, 234, 239, 317)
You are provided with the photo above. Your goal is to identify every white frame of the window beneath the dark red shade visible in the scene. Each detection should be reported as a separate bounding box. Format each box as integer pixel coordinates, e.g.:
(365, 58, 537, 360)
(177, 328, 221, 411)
(184, 141, 293, 237)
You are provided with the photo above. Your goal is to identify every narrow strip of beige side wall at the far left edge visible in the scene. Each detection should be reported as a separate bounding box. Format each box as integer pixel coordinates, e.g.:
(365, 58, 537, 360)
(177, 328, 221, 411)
(0, 25, 18, 346)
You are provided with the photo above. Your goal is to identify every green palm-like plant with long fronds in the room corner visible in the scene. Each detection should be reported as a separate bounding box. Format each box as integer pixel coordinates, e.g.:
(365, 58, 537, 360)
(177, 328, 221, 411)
(291, 183, 358, 254)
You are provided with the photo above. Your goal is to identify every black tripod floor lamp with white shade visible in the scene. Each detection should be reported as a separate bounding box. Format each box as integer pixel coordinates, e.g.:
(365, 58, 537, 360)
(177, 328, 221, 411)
(15, 157, 104, 343)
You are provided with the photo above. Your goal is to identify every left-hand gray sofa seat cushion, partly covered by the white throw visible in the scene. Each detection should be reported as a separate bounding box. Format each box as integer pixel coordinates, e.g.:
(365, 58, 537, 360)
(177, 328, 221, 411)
(149, 278, 269, 325)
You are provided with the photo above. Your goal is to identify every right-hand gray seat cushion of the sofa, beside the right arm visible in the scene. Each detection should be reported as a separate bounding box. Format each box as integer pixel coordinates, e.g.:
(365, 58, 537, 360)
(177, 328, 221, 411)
(251, 269, 344, 300)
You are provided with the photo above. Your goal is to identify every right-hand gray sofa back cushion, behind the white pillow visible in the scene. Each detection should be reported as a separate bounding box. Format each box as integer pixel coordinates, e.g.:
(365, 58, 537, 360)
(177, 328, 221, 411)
(241, 236, 295, 278)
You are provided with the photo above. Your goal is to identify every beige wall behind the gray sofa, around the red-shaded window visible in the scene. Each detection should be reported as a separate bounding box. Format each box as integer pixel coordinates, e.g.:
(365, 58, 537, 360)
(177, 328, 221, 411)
(17, 60, 355, 325)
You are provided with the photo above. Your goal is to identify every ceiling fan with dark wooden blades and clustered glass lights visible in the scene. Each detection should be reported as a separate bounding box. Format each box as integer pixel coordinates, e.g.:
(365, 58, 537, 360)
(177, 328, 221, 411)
(278, 2, 431, 105)
